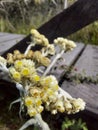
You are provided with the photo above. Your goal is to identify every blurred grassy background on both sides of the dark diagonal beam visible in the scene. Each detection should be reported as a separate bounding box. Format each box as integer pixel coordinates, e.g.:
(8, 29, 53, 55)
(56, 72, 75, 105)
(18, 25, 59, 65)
(0, 0, 98, 45)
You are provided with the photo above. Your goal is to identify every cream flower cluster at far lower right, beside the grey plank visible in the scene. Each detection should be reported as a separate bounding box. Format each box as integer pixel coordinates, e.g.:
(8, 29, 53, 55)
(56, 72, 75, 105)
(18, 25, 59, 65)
(46, 96, 85, 114)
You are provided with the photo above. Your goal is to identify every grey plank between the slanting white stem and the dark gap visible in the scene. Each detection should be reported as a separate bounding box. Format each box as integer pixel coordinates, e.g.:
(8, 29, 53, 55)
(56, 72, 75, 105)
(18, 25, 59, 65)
(50, 43, 85, 80)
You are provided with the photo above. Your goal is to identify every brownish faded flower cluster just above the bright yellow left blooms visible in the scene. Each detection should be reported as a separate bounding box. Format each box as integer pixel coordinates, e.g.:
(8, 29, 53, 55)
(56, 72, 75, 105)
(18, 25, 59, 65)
(7, 50, 50, 66)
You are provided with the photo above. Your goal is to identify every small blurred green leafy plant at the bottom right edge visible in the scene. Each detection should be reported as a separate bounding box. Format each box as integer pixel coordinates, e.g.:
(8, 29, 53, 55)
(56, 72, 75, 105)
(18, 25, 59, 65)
(62, 118, 88, 130)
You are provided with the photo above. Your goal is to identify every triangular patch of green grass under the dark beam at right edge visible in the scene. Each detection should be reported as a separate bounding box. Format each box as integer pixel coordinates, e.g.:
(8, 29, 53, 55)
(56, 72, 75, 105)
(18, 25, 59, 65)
(68, 21, 98, 45)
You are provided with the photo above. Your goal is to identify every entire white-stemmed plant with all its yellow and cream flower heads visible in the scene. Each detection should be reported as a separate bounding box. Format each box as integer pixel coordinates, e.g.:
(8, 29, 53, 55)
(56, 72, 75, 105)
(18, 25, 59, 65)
(0, 29, 85, 130)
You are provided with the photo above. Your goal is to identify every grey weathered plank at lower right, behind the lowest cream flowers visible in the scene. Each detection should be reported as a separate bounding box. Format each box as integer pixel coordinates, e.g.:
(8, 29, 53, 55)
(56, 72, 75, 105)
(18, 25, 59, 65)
(62, 81, 98, 119)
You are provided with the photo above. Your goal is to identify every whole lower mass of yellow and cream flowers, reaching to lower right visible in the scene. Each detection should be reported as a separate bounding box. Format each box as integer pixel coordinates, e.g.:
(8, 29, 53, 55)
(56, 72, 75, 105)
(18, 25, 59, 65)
(25, 75, 85, 117)
